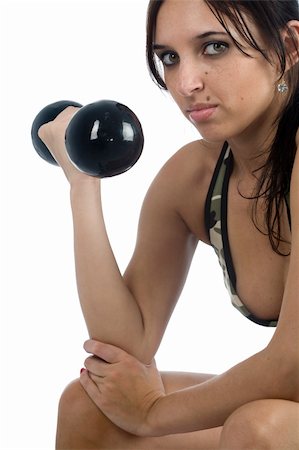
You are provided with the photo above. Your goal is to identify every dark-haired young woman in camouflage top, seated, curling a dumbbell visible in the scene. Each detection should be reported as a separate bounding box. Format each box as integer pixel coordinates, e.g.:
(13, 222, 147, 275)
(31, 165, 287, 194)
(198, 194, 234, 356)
(40, 0, 299, 450)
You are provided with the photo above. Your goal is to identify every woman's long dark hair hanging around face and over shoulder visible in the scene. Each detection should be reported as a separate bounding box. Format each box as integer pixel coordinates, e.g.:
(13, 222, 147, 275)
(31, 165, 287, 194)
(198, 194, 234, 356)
(146, 0, 299, 254)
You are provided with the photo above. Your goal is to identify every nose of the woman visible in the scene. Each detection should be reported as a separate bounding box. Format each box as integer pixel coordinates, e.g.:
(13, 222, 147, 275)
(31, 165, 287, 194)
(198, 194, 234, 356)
(176, 61, 204, 97)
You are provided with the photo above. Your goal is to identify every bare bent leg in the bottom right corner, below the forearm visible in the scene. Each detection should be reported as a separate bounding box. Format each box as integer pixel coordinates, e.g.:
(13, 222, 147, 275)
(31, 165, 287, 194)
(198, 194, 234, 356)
(220, 399, 299, 450)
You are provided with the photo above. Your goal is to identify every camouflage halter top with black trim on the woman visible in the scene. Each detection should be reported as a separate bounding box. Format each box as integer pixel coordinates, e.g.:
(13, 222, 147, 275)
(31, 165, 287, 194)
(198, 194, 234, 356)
(205, 143, 289, 327)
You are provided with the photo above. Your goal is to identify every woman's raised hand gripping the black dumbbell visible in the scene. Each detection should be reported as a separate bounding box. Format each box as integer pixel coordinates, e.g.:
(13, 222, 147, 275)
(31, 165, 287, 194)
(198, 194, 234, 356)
(38, 106, 91, 182)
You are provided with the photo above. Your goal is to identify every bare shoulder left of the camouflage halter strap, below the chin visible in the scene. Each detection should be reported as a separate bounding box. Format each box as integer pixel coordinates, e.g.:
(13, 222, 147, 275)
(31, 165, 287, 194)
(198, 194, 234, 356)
(145, 140, 223, 242)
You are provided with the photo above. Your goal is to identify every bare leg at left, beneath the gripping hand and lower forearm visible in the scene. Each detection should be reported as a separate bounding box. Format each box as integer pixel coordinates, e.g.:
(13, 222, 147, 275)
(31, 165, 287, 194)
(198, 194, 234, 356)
(56, 372, 222, 450)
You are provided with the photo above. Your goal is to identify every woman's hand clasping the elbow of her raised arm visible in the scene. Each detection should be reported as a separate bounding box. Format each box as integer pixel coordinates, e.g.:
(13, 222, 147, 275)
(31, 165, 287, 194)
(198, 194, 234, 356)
(80, 340, 165, 436)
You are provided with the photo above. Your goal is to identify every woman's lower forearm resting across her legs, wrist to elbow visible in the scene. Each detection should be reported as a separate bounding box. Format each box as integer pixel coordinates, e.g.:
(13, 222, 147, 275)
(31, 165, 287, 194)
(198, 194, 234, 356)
(149, 349, 298, 436)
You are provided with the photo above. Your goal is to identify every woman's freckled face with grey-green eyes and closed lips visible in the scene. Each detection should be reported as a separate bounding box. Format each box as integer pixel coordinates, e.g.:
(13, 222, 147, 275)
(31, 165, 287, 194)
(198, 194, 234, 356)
(155, 0, 278, 142)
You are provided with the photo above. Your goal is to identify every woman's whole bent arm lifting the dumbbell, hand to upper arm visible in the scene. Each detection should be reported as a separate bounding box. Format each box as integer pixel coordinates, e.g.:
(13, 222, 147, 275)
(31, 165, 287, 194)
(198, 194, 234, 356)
(39, 108, 209, 363)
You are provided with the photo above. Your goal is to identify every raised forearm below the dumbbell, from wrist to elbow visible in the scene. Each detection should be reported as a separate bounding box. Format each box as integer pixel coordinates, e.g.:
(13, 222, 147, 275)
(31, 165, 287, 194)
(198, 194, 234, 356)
(71, 178, 144, 360)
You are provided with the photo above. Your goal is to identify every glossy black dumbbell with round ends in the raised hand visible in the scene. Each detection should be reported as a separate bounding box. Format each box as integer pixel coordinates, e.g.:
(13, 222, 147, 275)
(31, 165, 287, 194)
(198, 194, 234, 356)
(31, 100, 144, 178)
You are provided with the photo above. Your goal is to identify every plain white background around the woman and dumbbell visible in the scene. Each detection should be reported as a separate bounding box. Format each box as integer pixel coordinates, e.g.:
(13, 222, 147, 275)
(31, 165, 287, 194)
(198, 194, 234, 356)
(0, 0, 273, 450)
